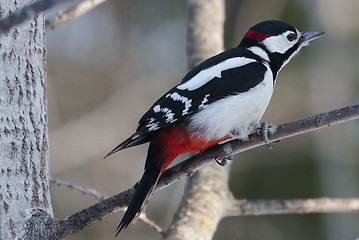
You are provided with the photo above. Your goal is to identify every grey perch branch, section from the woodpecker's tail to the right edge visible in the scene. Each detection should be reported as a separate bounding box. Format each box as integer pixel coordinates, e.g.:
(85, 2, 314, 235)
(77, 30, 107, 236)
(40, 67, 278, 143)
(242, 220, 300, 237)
(157, 104, 359, 189)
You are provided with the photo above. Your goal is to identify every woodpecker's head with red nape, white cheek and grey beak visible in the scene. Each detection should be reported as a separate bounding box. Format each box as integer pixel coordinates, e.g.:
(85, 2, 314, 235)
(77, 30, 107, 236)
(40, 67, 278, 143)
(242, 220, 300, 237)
(239, 20, 324, 73)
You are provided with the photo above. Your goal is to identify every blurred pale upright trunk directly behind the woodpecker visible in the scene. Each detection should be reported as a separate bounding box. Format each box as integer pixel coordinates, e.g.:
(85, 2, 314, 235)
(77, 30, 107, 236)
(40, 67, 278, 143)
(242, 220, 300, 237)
(165, 0, 231, 240)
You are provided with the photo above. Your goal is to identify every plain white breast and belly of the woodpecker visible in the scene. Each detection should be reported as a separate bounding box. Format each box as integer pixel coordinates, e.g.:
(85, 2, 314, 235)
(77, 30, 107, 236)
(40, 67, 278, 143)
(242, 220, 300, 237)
(188, 66, 274, 140)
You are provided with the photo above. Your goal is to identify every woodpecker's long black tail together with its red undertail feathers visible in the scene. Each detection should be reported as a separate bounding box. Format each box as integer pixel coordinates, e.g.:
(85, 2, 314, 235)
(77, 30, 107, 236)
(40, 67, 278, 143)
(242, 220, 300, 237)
(116, 125, 224, 236)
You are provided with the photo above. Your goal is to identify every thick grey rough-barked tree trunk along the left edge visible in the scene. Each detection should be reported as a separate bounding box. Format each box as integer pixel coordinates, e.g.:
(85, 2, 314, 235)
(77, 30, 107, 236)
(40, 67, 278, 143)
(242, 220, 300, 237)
(0, 0, 52, 239)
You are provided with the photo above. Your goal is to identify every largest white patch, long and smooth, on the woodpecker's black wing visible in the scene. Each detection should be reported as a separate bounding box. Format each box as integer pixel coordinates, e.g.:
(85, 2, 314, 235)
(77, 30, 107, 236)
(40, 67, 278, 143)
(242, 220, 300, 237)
(177, 57, 256, 91)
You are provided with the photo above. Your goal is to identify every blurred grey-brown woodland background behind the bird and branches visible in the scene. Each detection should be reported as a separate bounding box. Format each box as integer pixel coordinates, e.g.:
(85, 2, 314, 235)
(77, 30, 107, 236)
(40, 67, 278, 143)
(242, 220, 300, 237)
(47, 0, 359, 240)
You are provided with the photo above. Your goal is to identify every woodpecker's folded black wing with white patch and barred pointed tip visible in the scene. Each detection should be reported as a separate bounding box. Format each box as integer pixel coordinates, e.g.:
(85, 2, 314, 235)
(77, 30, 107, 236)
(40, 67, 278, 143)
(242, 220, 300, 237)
(107, 48, 267, 156)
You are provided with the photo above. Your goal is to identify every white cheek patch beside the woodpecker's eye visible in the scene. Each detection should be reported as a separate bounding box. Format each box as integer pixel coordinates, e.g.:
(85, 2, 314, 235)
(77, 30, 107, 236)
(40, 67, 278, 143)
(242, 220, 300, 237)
(262, 31, 300, 54)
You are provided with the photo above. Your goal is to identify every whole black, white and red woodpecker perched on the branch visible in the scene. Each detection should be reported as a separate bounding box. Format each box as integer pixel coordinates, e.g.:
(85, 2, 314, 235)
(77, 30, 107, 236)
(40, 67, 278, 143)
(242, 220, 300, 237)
(107, 20, 324, 236)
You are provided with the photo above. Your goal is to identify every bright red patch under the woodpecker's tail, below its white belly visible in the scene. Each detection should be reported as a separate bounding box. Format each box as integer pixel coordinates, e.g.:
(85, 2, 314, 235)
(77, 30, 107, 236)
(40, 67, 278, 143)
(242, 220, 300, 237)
(151, 125, 225, 174)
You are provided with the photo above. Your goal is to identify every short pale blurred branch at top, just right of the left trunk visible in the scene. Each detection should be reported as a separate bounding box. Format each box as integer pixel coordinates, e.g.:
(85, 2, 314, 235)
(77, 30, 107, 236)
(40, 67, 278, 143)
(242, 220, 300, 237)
(45, 0, 107, 30)
